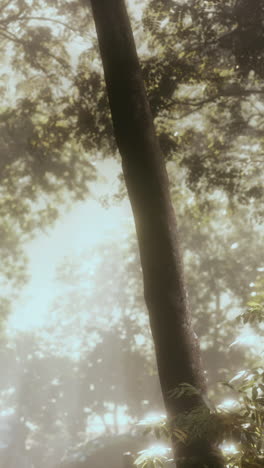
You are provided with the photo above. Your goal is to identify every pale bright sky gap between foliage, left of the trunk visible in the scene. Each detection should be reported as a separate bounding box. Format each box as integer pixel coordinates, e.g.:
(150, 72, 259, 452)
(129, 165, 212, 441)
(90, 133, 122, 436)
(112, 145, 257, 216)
(9, 160, 133, 330)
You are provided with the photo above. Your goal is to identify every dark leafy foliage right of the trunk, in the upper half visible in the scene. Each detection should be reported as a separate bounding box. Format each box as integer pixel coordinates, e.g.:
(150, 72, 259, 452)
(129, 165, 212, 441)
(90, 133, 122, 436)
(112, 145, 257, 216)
(143, 1, 263, 216)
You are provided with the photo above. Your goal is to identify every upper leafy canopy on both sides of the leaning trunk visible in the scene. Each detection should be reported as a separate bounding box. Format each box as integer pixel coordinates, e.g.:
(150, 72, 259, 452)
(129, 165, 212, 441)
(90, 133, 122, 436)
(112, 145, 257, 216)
(0, 0, 263, 326)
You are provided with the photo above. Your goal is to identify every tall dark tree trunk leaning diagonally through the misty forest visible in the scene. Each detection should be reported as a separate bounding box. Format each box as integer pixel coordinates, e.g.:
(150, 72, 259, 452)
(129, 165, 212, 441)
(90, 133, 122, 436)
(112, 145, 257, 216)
(91, 0, 224, 468)
